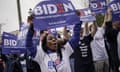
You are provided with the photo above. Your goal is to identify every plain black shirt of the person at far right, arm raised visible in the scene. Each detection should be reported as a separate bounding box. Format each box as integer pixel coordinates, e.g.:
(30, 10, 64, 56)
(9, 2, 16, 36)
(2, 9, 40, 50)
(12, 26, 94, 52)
(105, 22, 120, 72)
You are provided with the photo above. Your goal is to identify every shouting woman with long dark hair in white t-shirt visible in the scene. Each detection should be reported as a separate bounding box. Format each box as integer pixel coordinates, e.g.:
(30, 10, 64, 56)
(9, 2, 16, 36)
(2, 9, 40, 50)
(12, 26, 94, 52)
(34, 22, 82, 72)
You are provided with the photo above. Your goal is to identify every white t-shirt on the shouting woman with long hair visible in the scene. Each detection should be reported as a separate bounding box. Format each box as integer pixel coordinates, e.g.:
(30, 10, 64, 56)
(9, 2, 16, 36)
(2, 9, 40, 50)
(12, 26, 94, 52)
(34, 43, 73, 72)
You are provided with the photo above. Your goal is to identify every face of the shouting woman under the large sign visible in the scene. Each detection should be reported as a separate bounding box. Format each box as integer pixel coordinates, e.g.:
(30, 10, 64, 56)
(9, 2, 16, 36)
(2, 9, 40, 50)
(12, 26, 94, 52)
(47, 34, 57, 50)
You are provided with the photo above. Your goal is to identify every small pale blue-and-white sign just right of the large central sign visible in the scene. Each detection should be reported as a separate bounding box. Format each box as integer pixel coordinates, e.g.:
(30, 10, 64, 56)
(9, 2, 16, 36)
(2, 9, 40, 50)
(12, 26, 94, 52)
(80, 8, 96, 22)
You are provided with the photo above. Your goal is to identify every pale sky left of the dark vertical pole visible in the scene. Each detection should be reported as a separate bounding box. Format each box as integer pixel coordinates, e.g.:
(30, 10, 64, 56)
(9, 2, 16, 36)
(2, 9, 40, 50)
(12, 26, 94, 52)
(0, 0, 19, 32)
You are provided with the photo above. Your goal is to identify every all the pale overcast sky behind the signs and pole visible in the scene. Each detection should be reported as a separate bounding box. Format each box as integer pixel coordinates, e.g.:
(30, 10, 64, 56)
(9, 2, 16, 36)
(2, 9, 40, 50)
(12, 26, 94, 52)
(0, 0, 93, 32)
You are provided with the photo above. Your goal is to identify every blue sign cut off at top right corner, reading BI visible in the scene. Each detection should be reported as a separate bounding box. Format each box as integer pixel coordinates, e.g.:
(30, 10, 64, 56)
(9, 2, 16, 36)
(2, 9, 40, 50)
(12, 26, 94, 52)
(109, 0, 120, 21)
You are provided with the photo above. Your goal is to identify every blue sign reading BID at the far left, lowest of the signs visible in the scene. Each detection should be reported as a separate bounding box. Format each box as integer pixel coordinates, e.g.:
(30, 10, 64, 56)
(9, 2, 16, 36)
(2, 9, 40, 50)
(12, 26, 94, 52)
(2, 32, 26, 54)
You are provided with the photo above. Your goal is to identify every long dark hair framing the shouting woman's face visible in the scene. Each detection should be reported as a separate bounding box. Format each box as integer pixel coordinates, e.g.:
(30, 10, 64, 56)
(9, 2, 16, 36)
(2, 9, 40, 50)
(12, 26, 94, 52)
(42, 34, 62, 60)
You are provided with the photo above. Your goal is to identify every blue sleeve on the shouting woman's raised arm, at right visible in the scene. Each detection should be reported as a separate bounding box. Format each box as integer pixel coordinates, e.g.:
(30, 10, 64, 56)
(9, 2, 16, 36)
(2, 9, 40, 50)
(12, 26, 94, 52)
(69, 21, 82, 49)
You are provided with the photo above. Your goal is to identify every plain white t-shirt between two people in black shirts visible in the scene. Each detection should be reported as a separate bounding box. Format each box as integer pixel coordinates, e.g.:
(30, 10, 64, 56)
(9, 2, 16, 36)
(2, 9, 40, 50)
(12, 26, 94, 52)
(91, 28, 108, 61)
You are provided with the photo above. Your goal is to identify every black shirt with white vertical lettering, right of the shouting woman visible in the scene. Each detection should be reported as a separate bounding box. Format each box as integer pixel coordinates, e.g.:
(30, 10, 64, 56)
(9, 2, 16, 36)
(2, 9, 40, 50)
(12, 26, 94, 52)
(74, 34, 94, 72)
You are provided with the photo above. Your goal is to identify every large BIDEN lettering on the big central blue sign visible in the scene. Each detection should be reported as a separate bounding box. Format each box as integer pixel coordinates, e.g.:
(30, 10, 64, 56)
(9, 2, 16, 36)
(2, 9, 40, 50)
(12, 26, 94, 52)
(34, 3, 74, 15)
